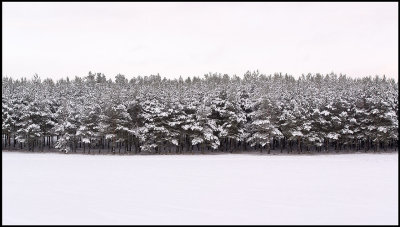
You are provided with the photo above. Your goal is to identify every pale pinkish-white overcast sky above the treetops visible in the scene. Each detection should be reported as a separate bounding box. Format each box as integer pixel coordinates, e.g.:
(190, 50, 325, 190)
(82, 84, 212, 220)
(2, 2, 399, 80)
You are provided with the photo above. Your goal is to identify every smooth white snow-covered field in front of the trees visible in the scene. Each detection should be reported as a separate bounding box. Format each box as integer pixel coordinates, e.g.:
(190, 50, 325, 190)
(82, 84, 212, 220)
(2, 152, 398, 225)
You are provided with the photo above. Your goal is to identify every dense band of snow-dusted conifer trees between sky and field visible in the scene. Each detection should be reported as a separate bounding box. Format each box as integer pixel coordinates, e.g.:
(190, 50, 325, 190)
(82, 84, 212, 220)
(2, 71, 399, 154)
